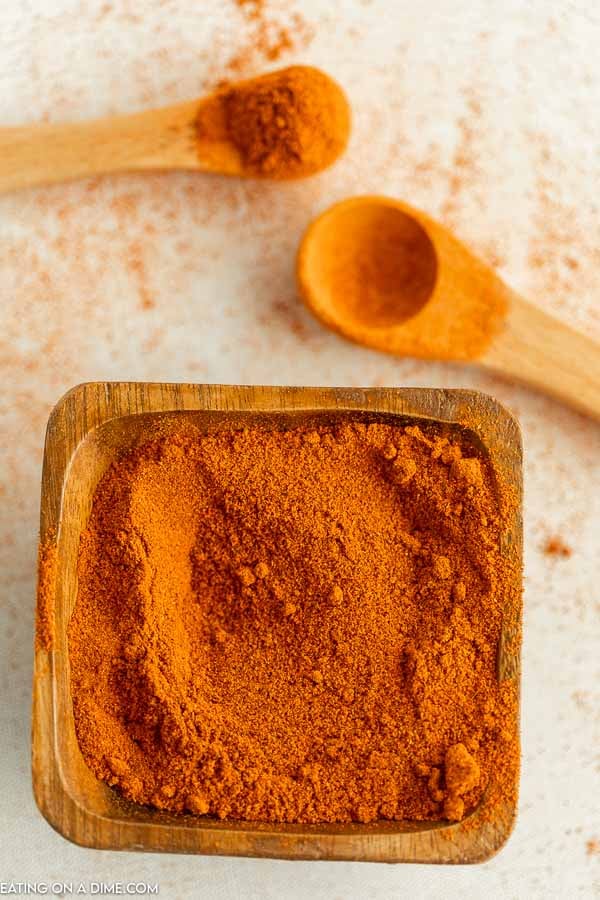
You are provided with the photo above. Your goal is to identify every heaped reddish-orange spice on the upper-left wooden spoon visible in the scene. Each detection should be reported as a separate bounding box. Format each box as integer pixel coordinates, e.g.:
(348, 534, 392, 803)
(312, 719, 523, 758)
(197, 66, 350, 179)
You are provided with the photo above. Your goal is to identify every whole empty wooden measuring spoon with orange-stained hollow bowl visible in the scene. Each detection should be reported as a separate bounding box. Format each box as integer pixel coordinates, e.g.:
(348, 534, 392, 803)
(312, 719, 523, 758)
(297, 196, 600, 419)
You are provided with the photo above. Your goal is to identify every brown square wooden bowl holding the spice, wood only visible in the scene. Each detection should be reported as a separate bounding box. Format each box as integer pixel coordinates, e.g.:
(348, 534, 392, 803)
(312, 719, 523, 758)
(32, 383, 522, 863)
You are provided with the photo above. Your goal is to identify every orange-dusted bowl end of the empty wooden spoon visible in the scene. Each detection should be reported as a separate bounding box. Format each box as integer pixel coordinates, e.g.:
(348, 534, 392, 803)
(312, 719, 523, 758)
(297, 196, 508, 360)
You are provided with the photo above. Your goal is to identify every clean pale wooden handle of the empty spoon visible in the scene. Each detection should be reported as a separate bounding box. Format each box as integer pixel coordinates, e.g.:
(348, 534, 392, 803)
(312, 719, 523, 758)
(480, 292, 600, 420)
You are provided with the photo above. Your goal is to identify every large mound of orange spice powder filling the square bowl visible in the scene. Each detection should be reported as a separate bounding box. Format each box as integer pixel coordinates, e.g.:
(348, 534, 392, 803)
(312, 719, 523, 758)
(69, 421, 519, 822)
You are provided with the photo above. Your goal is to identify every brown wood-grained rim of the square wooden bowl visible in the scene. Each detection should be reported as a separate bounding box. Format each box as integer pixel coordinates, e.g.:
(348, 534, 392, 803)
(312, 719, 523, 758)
(32, 382, 522, 863)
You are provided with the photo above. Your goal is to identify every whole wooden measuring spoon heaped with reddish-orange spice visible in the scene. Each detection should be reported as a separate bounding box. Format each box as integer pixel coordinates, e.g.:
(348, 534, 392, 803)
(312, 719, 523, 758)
(0, 66, 350, 192)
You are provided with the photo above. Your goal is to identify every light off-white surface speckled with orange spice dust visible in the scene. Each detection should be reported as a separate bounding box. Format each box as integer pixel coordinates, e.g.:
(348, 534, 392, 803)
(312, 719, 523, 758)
(0, 0, 600, 900)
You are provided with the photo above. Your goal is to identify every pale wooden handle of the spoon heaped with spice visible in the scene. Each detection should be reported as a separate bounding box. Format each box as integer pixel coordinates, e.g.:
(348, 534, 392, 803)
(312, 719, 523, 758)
(0, 102, 199, 193)
